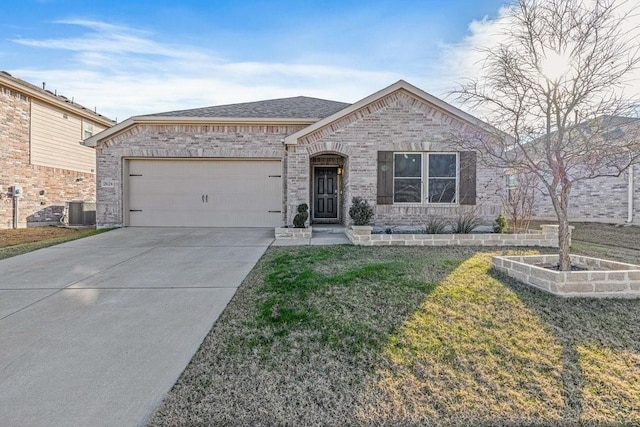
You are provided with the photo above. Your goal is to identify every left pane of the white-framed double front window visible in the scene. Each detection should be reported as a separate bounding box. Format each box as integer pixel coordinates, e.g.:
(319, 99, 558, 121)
(393, 153, 422, 203)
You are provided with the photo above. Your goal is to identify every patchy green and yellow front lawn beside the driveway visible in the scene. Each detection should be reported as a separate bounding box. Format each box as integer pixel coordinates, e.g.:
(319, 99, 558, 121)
(151, 246, 640, 426)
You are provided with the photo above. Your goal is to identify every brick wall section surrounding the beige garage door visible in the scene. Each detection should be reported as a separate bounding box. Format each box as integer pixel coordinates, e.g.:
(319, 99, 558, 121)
(96, 125, 308, 228)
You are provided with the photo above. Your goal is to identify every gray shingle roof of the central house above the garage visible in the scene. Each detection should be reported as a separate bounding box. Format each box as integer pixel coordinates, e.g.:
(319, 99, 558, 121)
(150, 96, 351, 119)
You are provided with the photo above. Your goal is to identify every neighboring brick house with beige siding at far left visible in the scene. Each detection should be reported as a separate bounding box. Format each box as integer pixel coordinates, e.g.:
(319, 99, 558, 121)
(0, 71, 114, 228)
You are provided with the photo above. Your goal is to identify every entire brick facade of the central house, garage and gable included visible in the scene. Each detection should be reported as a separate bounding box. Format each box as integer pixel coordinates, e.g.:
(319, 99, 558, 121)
(96, 85, 503, 227)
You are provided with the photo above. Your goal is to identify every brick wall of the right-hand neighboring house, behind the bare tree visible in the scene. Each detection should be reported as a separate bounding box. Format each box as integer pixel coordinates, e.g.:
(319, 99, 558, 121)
(534, 165, 640, 224)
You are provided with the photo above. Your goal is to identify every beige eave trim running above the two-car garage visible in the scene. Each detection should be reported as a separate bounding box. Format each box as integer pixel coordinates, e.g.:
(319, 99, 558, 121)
(82, 116, 320, 147)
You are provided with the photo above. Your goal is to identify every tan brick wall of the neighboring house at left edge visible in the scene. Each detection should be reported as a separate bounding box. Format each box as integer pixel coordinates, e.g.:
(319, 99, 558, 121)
(0, 86, 95, 228)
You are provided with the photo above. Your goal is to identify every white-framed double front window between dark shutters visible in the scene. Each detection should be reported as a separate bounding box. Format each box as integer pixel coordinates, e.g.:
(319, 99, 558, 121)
(393, 153, 458, 203)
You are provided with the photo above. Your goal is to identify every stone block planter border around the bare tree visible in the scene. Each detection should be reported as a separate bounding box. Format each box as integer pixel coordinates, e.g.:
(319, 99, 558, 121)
(492, 255, 640, 298)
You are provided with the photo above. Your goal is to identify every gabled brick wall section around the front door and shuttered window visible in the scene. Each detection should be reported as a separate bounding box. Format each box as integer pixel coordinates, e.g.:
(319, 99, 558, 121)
(287, 91, 503, 224)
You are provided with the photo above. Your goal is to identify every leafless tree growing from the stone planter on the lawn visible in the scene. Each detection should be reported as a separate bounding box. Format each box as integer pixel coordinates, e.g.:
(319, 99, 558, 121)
(453, 0, 640, 270)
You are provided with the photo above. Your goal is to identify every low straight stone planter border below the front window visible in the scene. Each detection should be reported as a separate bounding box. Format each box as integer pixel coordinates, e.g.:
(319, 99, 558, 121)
(345, 225, 573, 248)
